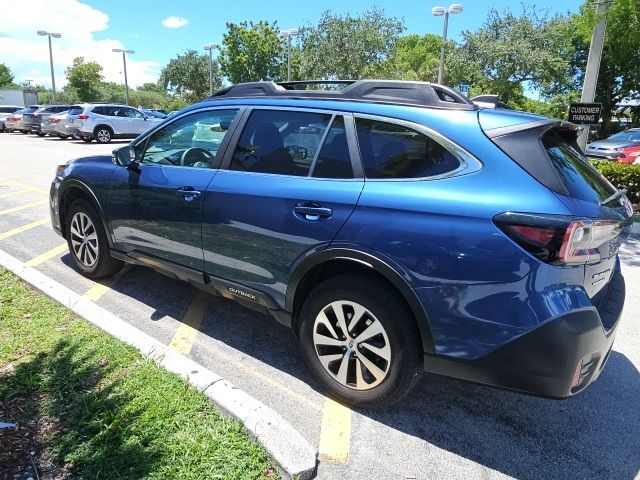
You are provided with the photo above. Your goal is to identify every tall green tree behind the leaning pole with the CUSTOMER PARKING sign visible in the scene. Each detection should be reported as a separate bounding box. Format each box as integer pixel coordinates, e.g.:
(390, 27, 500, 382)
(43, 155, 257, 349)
(574, 0, 640, 136)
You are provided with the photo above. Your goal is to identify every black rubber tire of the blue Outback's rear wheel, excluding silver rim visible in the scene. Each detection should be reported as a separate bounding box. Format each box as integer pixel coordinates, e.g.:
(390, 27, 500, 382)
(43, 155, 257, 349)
(299, 274, 423, 409)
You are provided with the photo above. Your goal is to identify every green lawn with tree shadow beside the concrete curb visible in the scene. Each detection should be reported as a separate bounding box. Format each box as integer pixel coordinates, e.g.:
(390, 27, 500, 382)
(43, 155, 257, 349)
(0, 269, 277, 480)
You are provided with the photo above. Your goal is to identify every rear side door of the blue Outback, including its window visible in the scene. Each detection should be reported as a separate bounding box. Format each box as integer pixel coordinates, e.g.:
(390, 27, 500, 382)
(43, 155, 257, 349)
(202, 109, 364, 301)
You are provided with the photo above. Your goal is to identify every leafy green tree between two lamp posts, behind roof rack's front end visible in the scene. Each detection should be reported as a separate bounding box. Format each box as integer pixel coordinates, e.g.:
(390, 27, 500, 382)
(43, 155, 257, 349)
(220, 22, 286, 83)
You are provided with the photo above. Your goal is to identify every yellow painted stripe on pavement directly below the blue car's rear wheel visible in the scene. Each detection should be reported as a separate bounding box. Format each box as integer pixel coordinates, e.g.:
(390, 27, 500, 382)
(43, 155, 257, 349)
(318, 398, 351, 463)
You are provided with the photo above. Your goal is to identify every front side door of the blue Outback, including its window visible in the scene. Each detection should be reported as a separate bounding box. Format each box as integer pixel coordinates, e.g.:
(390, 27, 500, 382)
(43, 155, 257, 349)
(108, 109, 237, 271)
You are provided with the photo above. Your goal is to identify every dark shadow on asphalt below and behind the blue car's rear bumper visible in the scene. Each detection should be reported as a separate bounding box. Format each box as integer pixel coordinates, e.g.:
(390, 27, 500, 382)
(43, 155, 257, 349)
(362, 351, 640, 480)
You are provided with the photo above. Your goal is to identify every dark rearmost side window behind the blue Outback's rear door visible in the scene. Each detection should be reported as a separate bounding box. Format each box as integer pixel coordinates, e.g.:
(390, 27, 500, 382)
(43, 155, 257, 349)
(356, 118, 460, 179)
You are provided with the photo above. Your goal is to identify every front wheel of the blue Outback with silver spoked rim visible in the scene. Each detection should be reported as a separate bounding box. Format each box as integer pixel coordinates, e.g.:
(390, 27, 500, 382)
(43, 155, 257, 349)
(65, 200, 123, 279)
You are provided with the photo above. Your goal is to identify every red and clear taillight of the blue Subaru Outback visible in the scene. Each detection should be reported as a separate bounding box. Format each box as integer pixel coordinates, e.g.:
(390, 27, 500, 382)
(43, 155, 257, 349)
(494, 213, 622, 265)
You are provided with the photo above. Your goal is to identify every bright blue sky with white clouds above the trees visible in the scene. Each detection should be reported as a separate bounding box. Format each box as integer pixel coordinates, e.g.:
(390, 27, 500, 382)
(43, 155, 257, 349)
(0, 0, 582, 88)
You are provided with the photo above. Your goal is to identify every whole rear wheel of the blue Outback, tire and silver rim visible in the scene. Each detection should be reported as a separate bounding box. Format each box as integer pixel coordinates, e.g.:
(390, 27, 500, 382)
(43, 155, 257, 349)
(299, 274, 423, 408)
